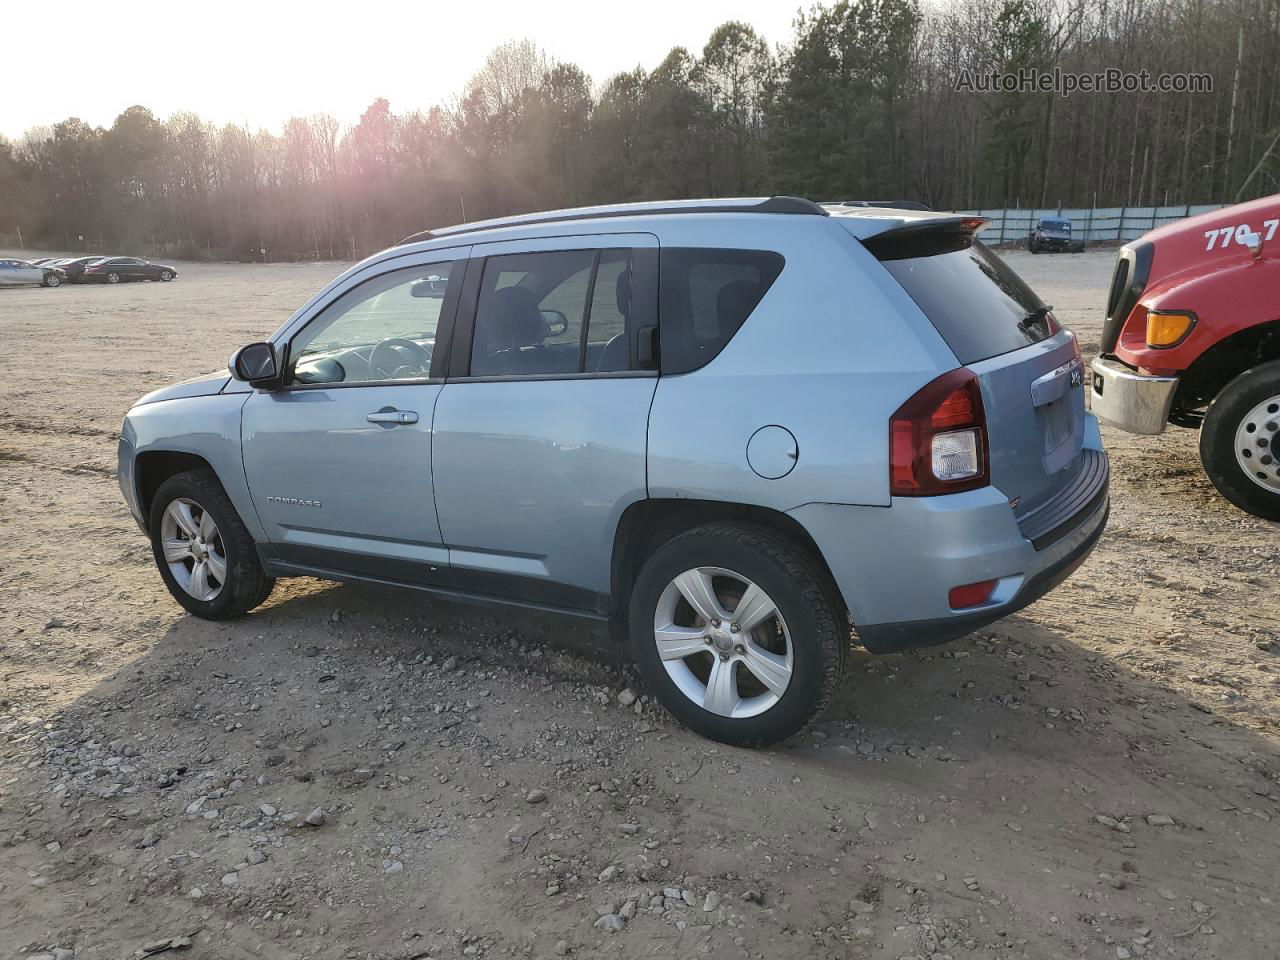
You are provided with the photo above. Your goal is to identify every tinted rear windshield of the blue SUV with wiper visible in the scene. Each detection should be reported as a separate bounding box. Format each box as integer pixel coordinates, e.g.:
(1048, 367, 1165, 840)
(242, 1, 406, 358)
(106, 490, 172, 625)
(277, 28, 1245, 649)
(864, 230, 1061, 364)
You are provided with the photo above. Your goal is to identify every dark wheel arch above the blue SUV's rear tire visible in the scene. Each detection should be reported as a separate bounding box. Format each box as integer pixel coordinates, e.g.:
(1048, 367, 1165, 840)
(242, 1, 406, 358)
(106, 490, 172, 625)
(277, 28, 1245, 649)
(609, 498, 847, 626)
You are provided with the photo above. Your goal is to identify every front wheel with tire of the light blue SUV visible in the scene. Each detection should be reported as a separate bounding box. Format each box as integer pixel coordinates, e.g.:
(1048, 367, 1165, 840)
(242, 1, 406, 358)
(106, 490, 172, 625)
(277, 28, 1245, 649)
(150, 470, 275, 620)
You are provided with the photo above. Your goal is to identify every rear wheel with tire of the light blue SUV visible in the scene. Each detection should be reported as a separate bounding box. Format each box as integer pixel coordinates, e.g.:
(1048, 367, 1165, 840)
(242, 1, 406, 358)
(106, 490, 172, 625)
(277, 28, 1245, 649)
(628, 524, 850, 746)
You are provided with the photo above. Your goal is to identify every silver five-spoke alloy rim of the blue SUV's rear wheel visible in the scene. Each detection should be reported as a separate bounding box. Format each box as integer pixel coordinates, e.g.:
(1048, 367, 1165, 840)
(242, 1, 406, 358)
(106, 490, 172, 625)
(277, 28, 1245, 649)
(653, 567, 795, 718)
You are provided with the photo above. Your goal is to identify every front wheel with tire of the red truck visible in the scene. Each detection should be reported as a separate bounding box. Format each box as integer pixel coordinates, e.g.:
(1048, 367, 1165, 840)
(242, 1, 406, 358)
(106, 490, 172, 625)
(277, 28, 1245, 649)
(1201, 360, 1280, 520)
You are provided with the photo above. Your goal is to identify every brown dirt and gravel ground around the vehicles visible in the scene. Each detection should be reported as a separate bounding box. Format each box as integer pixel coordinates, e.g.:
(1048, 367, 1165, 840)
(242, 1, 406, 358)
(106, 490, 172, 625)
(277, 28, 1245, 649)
(0, 251, 1280, 960)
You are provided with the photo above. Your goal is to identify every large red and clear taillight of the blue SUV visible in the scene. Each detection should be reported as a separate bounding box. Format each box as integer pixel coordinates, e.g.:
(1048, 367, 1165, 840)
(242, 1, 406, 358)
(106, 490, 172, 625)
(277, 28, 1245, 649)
(888, 367, 991, 497)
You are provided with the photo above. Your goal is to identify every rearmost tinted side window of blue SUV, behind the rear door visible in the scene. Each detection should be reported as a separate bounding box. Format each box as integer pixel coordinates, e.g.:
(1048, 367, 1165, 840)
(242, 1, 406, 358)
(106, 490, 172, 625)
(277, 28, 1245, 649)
(658, 247, 785, 374)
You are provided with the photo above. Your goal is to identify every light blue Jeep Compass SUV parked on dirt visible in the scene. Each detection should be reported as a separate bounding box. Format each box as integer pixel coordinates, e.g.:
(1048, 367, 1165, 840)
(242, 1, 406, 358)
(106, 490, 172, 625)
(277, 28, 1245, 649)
(119, 197, 1108, 745)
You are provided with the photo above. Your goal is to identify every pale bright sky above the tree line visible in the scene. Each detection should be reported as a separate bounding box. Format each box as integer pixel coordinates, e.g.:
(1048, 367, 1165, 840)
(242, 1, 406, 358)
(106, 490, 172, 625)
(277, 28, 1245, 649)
(0, 0, 809, 140)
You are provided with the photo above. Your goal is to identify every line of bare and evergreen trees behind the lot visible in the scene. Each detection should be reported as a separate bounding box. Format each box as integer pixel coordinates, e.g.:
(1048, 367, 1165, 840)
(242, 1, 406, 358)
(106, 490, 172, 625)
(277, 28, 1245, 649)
(0, 0, 1280, 257)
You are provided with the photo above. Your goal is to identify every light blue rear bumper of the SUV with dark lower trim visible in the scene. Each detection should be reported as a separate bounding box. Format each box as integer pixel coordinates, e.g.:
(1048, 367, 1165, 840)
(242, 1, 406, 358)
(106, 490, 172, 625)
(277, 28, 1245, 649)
(791, 426, 1111, 653)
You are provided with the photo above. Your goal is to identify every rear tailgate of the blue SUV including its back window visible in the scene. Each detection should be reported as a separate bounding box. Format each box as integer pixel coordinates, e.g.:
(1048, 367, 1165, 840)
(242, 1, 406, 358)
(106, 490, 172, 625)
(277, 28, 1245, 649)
(863, 224, 1093, 522)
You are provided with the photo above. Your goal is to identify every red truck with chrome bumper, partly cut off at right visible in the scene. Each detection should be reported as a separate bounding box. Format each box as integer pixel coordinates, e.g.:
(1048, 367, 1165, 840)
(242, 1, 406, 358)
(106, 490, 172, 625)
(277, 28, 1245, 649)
(1091, 195, 1280, 520)
